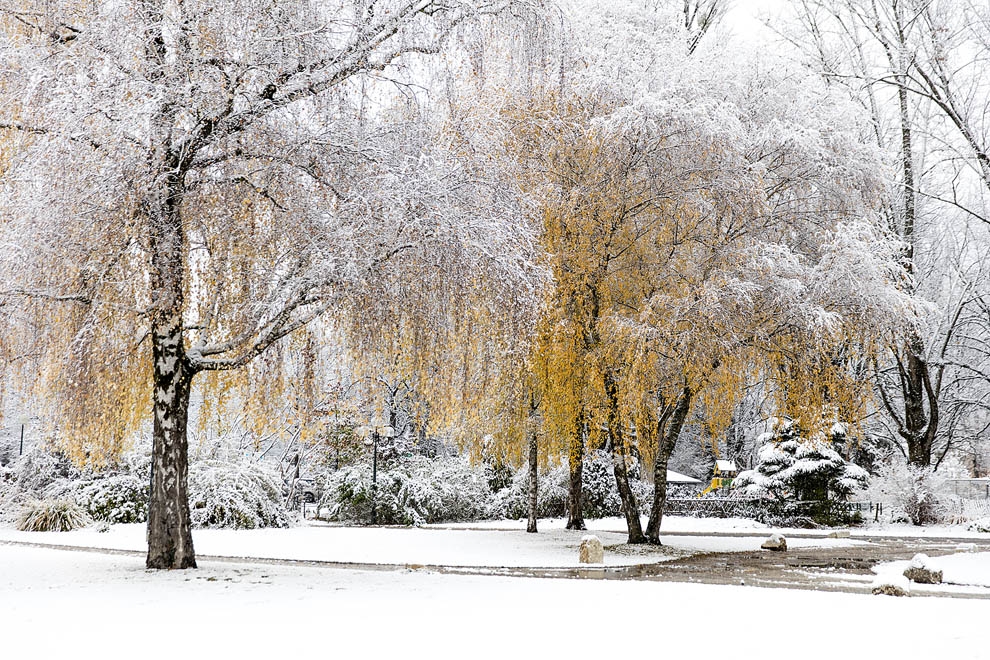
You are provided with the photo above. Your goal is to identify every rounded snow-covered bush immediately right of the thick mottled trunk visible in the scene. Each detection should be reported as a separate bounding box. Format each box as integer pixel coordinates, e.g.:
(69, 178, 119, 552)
(189, 461, 289, 529)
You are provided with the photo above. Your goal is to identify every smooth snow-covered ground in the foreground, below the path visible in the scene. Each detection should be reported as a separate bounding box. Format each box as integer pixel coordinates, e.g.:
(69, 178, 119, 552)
(0, 545, 990, 660)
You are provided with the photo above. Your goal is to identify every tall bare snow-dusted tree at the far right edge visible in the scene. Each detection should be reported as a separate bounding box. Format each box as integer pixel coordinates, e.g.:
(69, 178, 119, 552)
(793, 0, 990, 466)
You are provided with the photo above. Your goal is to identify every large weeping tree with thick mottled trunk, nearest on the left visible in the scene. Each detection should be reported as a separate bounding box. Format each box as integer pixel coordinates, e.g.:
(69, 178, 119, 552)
(0, 0, 544, 568)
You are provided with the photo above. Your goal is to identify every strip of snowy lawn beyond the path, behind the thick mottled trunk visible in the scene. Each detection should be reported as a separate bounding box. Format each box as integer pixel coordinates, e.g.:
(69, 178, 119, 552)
(0, 519, 863, 567)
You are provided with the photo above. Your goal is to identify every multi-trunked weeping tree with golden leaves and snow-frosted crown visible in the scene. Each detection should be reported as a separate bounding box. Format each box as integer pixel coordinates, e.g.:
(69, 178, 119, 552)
(494, 1, 923, 543)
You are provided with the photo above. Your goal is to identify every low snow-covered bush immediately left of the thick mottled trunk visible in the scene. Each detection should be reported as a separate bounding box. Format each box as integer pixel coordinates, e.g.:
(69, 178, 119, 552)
(45, 474, 148, 523)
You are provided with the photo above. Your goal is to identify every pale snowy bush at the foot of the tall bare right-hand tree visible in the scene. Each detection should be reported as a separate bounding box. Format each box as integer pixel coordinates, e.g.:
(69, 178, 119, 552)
(870, 458, 947, 525)
